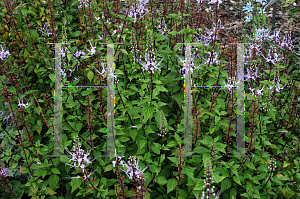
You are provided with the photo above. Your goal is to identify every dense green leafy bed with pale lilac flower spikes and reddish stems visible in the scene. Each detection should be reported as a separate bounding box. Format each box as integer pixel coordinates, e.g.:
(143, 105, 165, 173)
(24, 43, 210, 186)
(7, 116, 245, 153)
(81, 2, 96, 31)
(0, 0, 300, 199)
